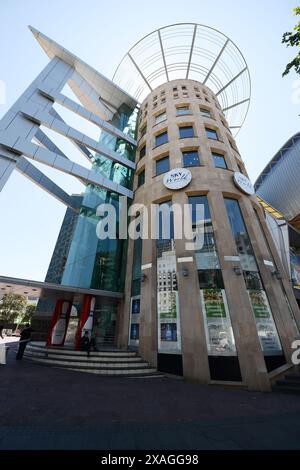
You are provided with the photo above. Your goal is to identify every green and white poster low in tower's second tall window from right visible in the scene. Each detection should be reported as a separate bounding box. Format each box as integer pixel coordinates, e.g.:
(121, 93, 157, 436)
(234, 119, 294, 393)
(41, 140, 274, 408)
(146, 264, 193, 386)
(200, 289, 236, 356)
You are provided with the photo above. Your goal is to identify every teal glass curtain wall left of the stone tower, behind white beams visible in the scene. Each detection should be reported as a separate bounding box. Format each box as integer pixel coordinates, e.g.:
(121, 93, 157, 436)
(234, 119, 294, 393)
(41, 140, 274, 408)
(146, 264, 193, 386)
(62, 106, 137, 292)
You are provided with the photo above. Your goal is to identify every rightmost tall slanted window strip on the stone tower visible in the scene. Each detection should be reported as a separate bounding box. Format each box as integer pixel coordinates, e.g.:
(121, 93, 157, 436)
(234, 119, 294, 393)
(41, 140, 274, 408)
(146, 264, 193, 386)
(225, 198, 282, 356)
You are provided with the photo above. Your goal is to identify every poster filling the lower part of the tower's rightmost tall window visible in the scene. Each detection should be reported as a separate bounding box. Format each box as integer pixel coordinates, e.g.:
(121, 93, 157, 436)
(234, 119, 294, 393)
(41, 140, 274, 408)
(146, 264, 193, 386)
(248, 290, 282, 356)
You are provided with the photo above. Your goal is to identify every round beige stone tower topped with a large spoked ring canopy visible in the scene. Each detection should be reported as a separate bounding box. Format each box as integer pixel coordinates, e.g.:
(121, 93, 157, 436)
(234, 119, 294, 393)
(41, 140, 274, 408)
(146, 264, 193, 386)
(116, 25, 300, 390)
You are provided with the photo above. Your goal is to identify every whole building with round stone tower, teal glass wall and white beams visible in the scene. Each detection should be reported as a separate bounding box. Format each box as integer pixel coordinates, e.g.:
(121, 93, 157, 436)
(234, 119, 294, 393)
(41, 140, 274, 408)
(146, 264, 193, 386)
(0, 24, 300, 390)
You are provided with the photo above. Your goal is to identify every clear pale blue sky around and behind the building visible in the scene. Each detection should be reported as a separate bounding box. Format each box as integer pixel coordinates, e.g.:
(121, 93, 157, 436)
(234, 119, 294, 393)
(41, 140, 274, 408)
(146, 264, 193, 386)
(0, 0, 300, 280)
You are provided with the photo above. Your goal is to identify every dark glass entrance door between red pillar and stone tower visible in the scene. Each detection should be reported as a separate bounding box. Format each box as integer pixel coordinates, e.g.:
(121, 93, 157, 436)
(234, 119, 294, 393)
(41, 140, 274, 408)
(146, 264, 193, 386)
(93, 305, 117, 348)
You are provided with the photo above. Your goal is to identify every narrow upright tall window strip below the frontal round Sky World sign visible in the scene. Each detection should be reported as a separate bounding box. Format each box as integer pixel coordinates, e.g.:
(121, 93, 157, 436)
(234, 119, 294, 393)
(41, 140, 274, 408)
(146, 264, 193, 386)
(156, 202, 181, 354)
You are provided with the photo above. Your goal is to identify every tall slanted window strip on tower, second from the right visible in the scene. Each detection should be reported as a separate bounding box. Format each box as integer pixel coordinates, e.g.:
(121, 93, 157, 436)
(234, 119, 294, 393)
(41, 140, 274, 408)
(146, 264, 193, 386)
(189, 196, 237, 356)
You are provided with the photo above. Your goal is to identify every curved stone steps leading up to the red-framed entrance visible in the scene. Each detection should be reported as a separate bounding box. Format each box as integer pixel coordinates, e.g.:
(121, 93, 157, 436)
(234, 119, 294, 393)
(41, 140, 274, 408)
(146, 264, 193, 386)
(24, 342, 162, 377)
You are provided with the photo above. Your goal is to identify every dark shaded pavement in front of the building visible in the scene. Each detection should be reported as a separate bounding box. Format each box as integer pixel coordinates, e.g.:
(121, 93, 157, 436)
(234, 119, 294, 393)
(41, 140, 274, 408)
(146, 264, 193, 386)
(0, 344, 300, 450)
